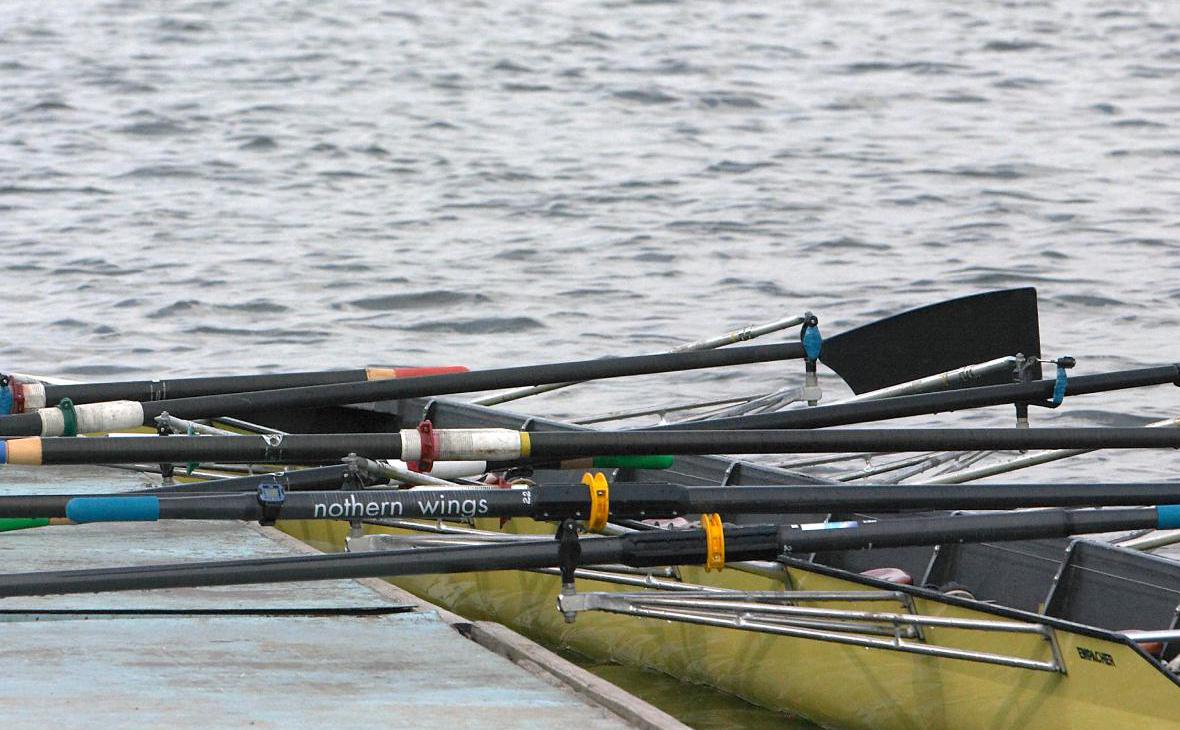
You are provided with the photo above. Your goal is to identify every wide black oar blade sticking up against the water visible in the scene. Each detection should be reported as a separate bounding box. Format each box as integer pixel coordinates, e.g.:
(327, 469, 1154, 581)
(820, 287, 1041, 394)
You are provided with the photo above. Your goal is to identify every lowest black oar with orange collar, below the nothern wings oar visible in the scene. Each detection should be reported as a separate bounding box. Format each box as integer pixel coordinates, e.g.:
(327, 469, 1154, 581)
(0, 506, 1180, 598)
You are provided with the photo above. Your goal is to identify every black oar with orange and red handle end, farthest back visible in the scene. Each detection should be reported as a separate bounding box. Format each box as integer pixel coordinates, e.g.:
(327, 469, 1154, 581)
(0, 366, 467, 413)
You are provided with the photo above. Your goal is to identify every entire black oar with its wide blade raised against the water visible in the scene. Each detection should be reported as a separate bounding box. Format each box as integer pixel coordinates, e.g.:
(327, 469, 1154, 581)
(0, 289, 1040, 436)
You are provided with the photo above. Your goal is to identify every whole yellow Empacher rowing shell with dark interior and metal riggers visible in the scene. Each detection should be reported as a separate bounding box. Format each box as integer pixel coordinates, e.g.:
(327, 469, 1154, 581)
(263, 399, 1180, 730)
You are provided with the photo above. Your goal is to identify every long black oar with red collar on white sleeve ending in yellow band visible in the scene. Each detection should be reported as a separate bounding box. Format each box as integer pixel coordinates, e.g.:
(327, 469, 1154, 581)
(11, 428, 1180, 469)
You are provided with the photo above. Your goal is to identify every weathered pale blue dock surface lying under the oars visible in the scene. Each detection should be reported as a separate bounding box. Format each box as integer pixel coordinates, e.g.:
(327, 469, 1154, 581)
(0, 468, 683, 730)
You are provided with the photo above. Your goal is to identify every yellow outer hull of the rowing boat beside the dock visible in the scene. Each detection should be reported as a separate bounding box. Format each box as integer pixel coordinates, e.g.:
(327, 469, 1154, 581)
(280, 519, 1180, 730)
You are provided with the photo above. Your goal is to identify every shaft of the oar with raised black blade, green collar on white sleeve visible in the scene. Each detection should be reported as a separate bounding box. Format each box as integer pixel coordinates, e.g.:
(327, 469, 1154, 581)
(0, 342, 804, 436)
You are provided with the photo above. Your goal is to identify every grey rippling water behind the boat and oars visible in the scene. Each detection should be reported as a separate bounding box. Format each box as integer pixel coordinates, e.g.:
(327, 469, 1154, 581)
(0, 0, 1180, 726)
